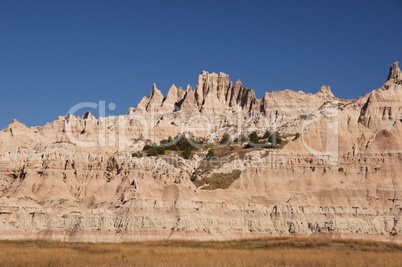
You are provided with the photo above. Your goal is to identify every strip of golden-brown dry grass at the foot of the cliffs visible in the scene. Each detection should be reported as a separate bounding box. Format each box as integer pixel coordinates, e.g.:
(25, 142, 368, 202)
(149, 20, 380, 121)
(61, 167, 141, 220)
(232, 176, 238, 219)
(0, 237, 402, 267)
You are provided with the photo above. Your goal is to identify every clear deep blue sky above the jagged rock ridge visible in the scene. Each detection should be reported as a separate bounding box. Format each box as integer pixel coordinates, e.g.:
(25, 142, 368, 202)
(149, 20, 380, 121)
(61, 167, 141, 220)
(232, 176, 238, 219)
(0, 0, 402, 128)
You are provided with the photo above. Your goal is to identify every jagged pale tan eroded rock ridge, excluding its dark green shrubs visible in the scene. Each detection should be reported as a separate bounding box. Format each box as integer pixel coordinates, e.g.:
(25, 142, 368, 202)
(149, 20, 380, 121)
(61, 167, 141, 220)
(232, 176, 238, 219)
(0, 62, 402, 243)
